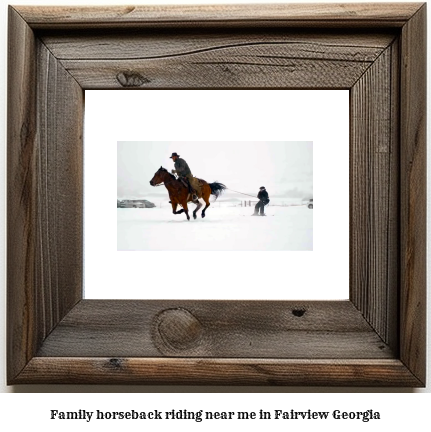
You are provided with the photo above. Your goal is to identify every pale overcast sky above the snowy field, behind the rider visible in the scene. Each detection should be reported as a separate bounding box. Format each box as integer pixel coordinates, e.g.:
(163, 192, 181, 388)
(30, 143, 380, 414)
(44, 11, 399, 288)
(117, 141, 313, 200)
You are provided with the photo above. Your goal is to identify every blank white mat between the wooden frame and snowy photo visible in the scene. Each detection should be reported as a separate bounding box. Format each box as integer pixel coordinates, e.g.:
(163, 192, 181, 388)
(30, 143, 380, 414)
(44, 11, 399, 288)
(84, 90, 349, 300)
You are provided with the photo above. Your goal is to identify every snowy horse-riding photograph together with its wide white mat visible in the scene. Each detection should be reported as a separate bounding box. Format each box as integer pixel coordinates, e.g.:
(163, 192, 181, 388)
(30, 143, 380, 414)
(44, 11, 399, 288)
(84, 90, 349, 300)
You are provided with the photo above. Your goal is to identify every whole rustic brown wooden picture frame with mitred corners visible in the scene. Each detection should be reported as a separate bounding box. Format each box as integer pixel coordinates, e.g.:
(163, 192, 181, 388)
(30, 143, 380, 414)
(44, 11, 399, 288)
(7, 3, 426, 387)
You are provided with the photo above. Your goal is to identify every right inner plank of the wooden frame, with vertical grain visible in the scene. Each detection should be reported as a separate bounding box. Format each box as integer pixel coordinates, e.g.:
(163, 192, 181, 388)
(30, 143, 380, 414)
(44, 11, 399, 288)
(350, 42, 399, 351)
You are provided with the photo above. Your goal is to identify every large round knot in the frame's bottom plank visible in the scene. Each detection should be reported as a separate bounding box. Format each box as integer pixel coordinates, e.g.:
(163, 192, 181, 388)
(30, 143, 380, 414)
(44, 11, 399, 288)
(156, 308, 203, 350)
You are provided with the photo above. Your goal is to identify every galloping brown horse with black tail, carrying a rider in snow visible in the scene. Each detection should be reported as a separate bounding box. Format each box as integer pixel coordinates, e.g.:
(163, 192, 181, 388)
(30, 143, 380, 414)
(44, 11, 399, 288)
(150, 167, 226, 220)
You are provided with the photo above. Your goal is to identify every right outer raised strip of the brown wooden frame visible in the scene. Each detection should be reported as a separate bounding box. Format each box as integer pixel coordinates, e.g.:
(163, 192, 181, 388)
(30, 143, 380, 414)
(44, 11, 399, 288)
(400, 4, 427, 382)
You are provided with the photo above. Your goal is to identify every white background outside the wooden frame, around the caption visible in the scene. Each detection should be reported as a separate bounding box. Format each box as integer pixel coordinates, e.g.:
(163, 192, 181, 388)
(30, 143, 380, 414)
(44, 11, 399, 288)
(0, 0, 431, 426)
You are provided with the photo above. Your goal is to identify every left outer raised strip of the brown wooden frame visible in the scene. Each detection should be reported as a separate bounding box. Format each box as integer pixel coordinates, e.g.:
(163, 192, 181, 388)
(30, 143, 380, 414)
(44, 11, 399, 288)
(7, 9, 40, 382)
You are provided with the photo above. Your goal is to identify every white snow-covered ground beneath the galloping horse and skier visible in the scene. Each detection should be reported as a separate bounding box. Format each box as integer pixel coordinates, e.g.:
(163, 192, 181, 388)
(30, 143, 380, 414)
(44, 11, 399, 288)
(117, 202, 313, 251)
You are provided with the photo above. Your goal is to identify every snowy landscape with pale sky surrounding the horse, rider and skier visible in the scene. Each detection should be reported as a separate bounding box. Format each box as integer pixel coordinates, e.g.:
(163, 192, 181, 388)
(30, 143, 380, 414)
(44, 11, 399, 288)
(117, 141, 313, 251)
